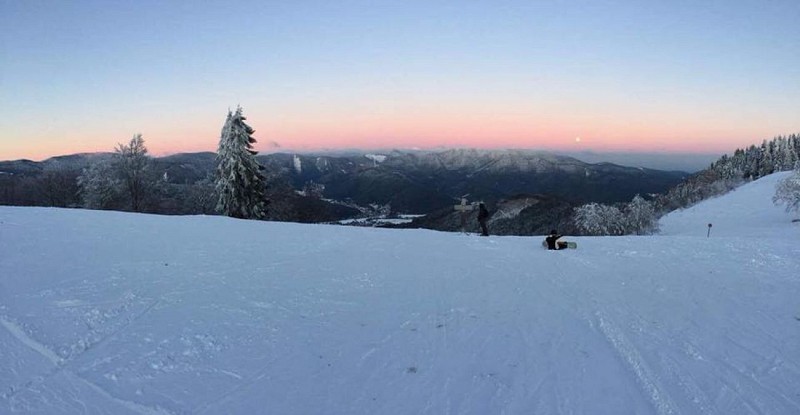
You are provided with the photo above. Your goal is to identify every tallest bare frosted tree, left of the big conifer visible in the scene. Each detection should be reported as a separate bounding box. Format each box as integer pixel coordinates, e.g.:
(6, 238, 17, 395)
(113, 134, 156, 212)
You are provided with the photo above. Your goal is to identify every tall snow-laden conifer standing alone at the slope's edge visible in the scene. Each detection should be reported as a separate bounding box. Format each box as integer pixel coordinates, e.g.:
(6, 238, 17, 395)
(215, 107, 267, 219)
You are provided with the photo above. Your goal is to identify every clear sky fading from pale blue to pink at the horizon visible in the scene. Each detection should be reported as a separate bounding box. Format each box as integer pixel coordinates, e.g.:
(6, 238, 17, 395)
(0, 0, 800, 160)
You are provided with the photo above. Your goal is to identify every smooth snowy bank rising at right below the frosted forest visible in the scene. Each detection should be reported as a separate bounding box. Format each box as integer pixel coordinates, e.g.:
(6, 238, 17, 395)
(659, 172, 800, 237)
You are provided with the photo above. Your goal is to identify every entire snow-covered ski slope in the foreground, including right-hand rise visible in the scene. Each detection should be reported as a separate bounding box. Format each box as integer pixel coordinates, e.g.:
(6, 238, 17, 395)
(0, 176, 800, 414)
